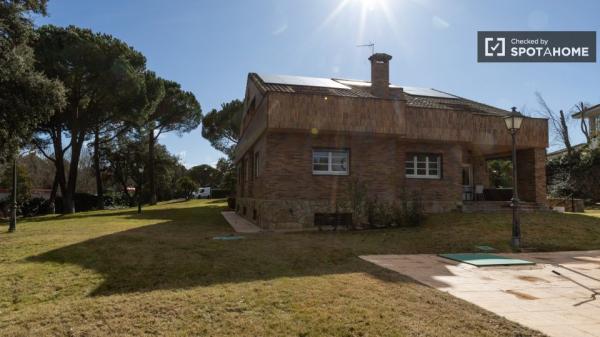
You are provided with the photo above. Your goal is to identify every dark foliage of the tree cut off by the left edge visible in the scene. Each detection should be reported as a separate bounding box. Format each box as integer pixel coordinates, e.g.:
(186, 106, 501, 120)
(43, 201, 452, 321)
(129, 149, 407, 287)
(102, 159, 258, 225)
(0, 0, 65, 162)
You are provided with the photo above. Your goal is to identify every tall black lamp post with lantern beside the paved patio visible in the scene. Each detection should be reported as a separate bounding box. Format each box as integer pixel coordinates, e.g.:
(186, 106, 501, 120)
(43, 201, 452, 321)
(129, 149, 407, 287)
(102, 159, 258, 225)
(504, 107, 524, 248)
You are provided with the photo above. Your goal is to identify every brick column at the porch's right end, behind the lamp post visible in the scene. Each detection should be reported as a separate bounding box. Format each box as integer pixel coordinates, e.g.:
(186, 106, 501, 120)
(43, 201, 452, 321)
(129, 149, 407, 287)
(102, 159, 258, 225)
(517, 148, 546, 204)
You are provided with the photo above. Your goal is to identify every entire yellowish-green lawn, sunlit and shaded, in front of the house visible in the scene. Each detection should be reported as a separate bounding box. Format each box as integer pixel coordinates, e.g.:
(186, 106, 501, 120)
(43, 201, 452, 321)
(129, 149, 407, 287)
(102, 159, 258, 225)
(0, 201, 600, 336)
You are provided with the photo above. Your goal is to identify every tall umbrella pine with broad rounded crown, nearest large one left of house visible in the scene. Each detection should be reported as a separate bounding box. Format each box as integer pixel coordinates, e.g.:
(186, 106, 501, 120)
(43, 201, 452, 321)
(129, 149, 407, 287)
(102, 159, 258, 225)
(35, 25, 146, 212)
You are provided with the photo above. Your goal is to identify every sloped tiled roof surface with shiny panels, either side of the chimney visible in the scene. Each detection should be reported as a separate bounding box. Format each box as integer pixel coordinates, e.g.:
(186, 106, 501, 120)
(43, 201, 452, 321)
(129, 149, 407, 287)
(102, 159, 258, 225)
(249, 73, 509, 115)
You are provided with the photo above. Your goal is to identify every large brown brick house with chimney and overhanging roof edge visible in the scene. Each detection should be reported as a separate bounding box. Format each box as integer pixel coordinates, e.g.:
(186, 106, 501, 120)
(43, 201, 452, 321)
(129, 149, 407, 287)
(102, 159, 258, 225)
(235, 54, 548, 229)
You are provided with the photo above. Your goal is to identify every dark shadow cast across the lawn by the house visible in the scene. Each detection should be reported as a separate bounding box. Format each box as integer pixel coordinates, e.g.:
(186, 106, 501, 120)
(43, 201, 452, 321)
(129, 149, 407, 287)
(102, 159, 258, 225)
(28, 204, 600, 296)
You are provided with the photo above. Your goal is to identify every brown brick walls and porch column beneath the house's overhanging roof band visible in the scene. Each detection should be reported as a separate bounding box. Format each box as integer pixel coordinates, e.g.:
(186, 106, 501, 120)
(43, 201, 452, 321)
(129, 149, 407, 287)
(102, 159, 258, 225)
(238, 131, 546, 229)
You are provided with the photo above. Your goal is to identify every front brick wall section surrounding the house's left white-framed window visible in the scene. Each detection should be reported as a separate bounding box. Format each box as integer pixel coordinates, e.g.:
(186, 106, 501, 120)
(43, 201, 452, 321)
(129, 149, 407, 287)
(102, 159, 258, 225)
(264, 133, 404, 202)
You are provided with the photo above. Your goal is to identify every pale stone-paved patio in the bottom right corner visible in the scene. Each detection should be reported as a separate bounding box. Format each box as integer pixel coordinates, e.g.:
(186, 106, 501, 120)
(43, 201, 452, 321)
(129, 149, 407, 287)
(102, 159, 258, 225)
(361, 251, 600, 337)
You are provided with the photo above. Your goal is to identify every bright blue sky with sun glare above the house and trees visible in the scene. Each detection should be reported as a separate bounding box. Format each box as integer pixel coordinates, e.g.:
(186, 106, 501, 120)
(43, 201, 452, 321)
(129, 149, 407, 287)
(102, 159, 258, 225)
(36, 0, 600, 167)
